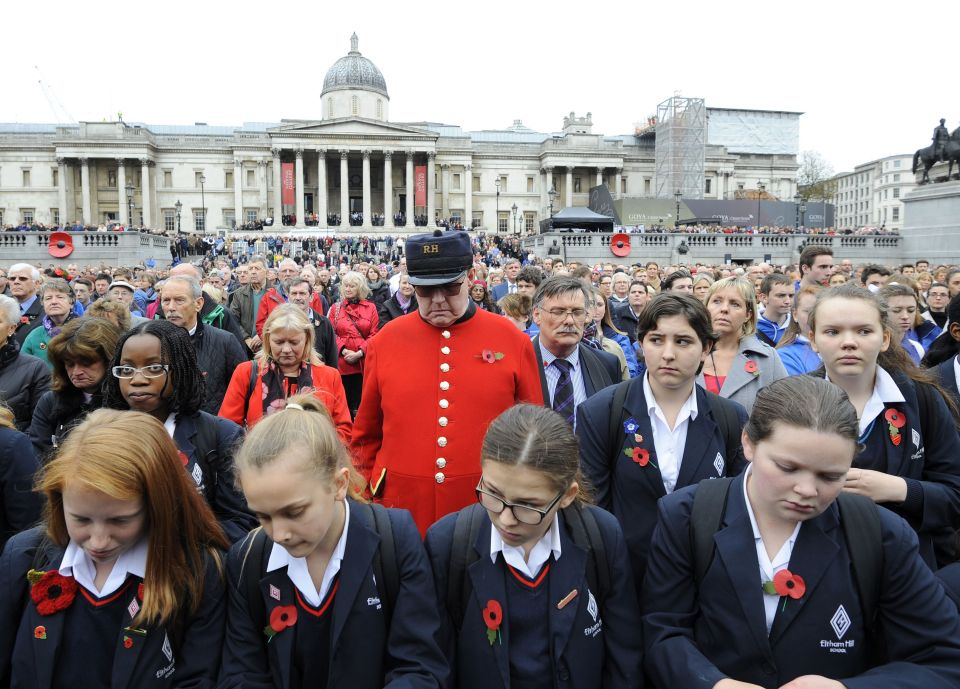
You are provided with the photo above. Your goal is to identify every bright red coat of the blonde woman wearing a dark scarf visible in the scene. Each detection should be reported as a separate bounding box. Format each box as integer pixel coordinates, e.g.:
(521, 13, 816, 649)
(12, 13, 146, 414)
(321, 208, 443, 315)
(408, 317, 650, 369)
(218, 361, 353, 446)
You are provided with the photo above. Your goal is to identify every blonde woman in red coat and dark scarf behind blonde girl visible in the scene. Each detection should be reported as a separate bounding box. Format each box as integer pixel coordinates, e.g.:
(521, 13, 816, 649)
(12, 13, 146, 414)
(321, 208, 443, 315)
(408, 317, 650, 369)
(220, 304, 353, 444)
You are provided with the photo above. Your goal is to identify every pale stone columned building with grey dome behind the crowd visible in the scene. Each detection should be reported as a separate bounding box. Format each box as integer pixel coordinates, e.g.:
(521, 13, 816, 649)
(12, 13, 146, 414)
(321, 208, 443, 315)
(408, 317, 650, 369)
(0, 35, 800, 234)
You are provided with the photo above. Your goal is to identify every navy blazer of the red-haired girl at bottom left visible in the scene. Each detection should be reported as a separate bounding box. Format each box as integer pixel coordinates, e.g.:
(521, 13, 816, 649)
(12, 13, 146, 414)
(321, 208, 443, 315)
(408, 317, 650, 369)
(0, 527, 226, 689)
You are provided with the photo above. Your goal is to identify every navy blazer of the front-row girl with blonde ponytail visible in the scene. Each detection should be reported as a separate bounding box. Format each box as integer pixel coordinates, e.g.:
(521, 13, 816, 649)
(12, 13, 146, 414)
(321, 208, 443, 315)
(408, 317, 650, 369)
(219, 500, 449, 689)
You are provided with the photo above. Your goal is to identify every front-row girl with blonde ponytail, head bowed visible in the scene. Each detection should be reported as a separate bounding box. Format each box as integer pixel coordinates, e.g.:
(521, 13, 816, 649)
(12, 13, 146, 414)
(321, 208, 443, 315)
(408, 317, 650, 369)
(220, 394, 448, 689)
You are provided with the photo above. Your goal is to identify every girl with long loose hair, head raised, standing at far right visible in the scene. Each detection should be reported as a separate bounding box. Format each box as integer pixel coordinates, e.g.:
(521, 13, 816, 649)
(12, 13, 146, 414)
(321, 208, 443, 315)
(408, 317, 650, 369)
(810, 283, 960, 569)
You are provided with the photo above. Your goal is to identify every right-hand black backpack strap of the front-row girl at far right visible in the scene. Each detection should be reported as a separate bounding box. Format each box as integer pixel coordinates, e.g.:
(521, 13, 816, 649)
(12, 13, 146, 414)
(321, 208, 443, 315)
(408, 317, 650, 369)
(837, 493, 883, 630)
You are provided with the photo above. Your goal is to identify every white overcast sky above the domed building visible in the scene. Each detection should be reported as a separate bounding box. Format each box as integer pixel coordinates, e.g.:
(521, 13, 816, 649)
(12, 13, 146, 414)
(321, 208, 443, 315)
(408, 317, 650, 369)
(0, 0, 960, 177)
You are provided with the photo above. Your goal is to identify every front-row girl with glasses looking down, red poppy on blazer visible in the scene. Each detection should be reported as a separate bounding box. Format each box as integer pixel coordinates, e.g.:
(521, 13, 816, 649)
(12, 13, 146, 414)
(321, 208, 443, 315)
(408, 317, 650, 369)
(426, 404, 642, 689)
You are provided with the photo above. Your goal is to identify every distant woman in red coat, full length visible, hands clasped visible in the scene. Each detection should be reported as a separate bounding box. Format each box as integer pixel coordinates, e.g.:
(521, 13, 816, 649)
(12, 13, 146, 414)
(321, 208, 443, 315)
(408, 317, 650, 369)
(327, 271, 380, 416)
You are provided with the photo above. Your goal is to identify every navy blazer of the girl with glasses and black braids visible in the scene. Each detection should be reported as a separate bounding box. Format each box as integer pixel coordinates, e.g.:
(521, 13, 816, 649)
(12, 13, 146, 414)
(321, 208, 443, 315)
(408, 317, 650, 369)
(173, 411, 257, 543)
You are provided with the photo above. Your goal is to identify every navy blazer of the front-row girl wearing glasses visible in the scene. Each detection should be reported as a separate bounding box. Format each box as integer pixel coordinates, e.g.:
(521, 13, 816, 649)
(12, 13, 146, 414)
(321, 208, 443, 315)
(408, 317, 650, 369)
(426, 505, 642, 689)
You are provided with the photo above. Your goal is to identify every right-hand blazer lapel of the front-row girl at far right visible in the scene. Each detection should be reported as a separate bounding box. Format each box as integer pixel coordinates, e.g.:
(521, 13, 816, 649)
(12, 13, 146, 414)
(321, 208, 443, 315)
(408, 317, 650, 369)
(770, 505, 840, 646)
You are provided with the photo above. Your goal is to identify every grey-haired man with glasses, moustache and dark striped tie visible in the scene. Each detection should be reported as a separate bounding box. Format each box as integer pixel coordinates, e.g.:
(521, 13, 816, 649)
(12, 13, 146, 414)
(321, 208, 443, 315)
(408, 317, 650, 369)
(533, 276, 620, 425)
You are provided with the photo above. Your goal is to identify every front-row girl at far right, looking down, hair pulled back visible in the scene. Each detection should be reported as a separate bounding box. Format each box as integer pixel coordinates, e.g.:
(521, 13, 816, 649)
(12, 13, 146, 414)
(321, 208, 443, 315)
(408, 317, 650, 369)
(643, 376, 960, 689)
